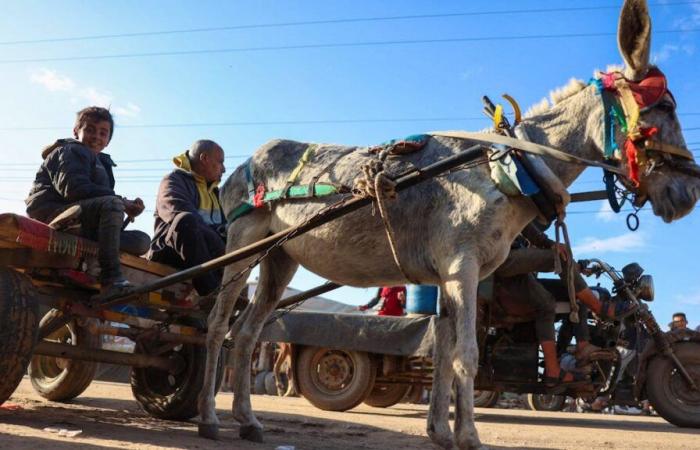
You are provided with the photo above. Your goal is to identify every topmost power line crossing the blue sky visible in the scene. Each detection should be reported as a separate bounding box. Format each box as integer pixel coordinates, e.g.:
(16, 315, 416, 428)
(0, 1, 700, 46)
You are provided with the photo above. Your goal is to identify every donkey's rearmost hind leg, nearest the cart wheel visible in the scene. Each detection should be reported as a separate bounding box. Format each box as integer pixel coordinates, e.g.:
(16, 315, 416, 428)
(198, 214, 269, 439)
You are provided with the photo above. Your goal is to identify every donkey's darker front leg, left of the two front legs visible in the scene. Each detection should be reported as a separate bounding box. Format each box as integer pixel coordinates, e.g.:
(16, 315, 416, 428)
(428, 289, 455, 448)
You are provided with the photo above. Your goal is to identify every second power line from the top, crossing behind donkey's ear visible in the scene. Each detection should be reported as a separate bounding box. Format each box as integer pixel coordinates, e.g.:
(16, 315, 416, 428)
(0, 28, 700, 64)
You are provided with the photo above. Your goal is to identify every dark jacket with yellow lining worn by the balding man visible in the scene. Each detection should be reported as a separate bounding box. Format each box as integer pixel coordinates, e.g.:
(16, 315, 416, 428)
(150, 153, 226, 253)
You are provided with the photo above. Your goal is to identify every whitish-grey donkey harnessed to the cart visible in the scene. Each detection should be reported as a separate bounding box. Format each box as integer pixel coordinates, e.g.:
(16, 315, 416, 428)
(199, 0, 700, 449)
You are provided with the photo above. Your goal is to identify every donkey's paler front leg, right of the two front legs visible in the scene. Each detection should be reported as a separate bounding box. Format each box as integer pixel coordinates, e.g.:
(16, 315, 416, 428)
(443, 264, 483, 449)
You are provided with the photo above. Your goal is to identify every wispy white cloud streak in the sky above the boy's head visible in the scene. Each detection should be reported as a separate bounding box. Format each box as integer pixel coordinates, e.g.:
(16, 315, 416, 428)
(30, 68, 141, 118)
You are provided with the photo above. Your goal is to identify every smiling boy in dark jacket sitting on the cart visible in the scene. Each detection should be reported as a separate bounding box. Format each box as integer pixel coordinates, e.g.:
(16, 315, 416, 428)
(25, 106, 150, 296)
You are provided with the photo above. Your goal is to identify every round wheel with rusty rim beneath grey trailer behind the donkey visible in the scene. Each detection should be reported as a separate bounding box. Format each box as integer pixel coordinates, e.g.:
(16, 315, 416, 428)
(296, 347, 376, 411)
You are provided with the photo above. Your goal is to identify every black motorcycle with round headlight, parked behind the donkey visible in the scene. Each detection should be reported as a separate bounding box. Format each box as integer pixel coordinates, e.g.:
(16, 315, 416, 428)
(475, 259, 700, 427)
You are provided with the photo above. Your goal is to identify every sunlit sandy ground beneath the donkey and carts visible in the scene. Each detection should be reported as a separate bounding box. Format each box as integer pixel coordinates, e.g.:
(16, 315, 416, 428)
(0, 379, 700, 450)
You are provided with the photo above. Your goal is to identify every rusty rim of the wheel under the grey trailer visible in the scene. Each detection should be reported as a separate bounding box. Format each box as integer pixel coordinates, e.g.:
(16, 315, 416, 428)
(311, 350, 356, 395)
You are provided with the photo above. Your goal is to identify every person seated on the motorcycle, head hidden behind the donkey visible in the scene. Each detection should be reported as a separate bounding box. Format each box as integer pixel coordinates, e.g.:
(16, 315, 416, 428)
(495, 224, 633, 386)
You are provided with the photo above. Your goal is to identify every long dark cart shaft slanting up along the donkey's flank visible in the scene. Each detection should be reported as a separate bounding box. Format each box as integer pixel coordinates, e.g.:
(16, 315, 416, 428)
(101, 144, 484, 307)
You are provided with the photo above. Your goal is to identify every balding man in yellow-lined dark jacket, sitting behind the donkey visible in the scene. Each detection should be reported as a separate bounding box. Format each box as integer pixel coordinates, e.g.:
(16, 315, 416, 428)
(147, 140, 226, 296)
